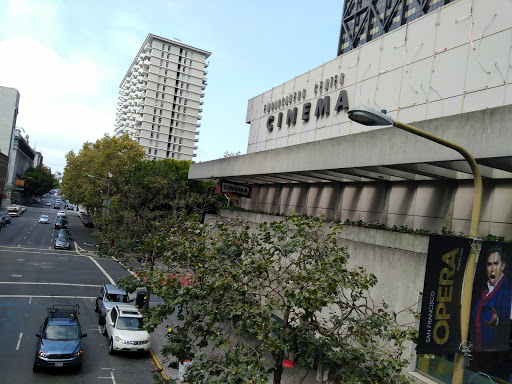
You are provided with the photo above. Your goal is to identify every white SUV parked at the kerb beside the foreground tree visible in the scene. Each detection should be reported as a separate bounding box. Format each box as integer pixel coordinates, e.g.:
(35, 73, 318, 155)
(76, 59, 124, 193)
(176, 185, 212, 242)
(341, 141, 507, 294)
(103, 305, 151, 354)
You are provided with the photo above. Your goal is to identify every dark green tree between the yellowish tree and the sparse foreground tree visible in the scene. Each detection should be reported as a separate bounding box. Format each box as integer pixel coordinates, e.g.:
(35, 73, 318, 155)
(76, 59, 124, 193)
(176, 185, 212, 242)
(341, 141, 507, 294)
(97, 159, 222, 310)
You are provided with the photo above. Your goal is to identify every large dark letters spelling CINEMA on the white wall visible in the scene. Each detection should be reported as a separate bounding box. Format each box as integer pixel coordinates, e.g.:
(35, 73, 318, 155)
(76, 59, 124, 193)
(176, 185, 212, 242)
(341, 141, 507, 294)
(267, 89, 348, 132)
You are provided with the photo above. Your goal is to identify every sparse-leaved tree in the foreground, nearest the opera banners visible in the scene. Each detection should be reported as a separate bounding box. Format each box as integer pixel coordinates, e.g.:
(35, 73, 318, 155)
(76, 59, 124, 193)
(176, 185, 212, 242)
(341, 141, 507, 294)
(120, 215, 415, 384)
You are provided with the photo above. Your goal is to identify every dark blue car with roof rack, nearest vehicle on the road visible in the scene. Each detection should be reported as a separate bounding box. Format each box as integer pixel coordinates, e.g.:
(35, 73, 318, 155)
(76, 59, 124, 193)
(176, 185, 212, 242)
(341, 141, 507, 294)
(33, 305, 87, 371)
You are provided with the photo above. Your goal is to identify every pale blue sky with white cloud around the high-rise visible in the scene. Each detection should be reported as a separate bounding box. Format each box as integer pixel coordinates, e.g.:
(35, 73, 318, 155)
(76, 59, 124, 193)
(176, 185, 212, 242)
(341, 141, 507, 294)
(0, 0, 343, 173)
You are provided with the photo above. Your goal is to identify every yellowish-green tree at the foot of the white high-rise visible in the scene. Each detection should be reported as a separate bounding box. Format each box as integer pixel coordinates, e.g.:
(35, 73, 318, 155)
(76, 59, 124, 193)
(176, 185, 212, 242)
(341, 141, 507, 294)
(61, 134, 144, 211)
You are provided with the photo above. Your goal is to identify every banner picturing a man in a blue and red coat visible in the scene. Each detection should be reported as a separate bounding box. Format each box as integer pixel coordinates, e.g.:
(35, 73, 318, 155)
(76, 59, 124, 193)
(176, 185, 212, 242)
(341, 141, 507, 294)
(469, 241, 512, 352)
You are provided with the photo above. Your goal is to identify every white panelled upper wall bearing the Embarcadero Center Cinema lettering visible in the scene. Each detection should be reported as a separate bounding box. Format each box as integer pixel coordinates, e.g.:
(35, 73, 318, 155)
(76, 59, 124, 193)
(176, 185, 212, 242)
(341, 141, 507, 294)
(246, 0, 512, 153)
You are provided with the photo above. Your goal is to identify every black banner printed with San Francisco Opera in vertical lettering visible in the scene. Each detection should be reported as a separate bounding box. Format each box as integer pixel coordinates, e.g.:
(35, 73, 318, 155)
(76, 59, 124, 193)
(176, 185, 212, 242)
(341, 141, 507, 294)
(416, 235, 472, 354)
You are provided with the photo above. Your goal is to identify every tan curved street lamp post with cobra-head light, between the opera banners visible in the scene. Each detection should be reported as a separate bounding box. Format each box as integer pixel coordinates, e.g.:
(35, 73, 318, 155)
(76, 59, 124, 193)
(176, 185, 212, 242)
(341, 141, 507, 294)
(348, 106, 482, 384)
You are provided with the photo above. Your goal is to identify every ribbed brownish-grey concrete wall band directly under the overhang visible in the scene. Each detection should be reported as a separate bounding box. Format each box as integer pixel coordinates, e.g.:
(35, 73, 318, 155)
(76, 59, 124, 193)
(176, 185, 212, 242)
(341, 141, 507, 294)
(242, 180, 512, 239)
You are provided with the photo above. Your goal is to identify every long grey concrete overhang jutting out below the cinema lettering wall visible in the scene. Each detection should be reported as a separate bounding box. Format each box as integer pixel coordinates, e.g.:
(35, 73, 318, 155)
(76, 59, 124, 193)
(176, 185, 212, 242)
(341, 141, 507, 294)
(189, 106, 512, 184)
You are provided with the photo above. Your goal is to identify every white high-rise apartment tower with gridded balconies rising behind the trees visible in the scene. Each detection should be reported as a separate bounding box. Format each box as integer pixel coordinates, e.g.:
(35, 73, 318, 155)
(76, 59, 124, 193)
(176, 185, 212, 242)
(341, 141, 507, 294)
(115, 34, 211, 160)
